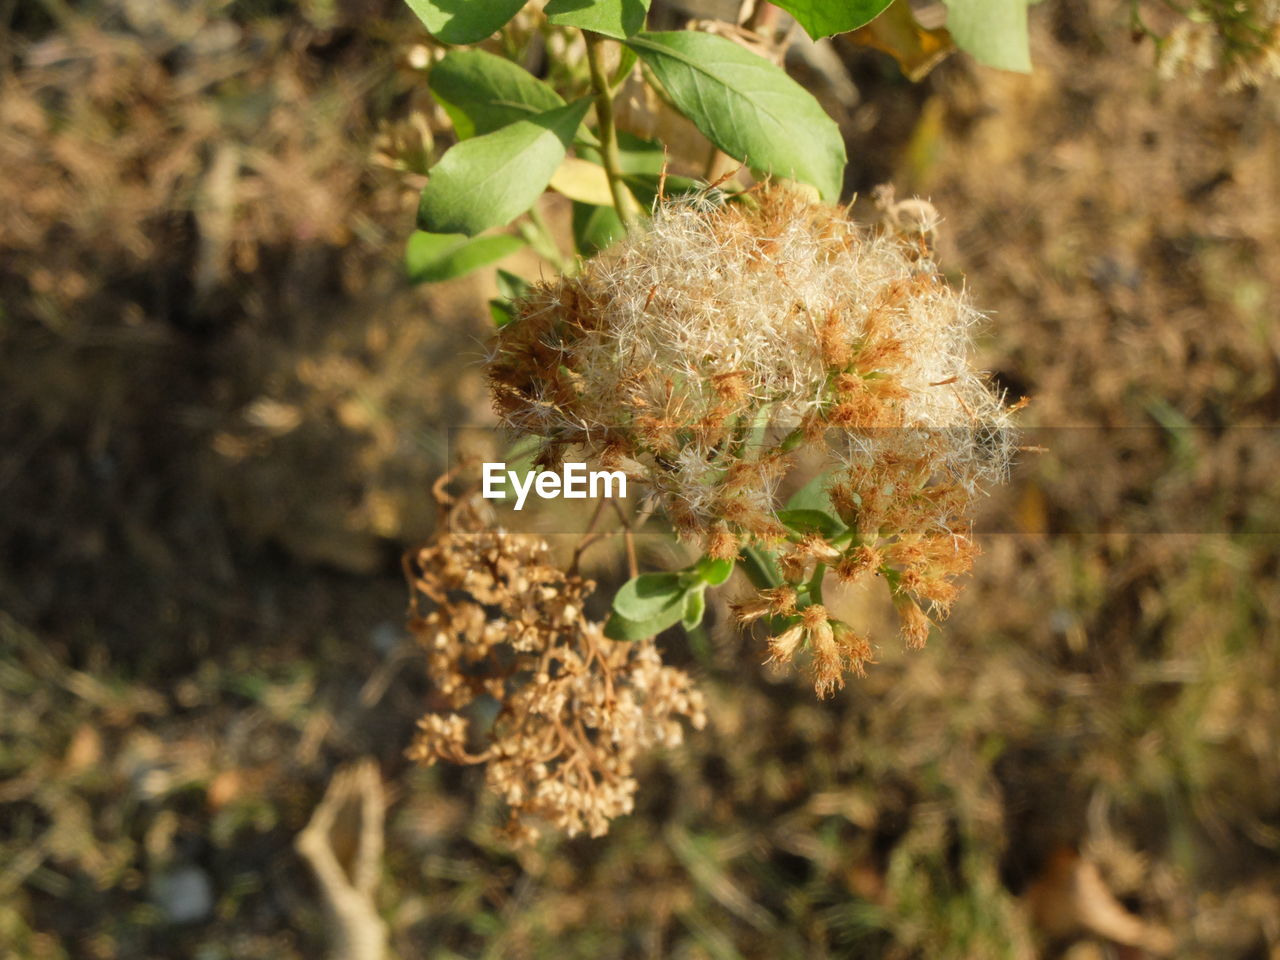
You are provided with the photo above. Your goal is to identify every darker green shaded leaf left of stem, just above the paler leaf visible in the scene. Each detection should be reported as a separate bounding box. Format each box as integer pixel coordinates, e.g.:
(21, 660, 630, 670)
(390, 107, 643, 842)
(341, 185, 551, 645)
(428, 50, 564, 140)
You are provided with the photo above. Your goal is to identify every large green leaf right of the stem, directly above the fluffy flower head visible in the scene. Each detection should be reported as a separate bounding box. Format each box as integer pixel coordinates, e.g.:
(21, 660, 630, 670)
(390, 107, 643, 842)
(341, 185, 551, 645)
(626, 31, 845, 201)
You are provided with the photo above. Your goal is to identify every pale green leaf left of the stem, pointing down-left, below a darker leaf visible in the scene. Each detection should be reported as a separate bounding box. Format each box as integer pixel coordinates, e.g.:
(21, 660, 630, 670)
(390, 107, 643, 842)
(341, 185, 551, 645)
(417, 97, 591, 236)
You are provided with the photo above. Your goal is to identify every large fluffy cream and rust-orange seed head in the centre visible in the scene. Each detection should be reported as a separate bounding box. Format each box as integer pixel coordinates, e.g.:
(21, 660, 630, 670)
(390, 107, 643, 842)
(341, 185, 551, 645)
(489, 187, 1012, 694)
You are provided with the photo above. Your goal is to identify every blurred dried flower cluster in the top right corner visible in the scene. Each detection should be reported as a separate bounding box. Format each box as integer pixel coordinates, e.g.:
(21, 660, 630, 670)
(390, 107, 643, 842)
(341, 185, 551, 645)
(1158, 0, 1280, 90)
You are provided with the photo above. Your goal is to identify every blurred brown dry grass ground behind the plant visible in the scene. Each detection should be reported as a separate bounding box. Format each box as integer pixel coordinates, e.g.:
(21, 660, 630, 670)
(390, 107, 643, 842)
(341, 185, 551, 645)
(0, 0, 1280, 960)
